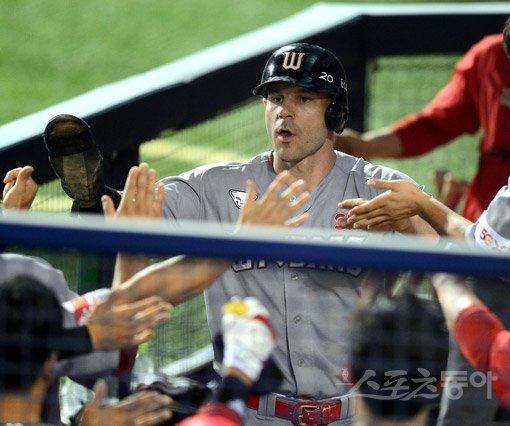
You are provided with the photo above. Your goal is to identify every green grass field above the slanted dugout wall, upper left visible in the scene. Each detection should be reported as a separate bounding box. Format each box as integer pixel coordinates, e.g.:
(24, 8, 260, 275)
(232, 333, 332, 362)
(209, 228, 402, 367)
(0, 0, 502, 124)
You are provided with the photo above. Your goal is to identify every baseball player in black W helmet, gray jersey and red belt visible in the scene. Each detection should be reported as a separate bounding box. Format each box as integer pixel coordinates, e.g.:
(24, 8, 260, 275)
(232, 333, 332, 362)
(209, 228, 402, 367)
(162, 43, 430, 425)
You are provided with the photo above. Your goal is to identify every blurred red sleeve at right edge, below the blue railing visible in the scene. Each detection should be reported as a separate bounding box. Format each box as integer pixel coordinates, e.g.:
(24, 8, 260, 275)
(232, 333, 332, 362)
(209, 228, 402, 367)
(453, 305, 510, 408)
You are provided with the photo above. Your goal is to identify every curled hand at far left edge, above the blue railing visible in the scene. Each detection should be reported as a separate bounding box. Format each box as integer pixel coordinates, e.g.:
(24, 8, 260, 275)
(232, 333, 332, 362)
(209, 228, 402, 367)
(3, 166, 38, 210)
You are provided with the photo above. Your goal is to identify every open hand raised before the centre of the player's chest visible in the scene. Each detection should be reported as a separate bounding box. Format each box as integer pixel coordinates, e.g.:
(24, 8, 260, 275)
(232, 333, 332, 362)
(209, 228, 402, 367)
(237, 171, 310, 227)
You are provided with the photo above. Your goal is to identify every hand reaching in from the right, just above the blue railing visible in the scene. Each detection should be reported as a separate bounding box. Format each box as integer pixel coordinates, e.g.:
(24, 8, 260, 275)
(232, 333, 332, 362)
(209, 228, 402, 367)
(337, 179, 426, 231)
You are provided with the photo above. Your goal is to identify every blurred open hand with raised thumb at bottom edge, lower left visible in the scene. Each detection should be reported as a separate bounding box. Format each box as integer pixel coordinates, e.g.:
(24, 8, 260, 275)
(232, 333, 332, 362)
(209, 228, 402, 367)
(80, 379, 172, 426)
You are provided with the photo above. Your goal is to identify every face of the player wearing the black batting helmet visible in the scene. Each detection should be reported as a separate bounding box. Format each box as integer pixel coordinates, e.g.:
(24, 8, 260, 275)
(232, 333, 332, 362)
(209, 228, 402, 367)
(264, 83, 331, 164)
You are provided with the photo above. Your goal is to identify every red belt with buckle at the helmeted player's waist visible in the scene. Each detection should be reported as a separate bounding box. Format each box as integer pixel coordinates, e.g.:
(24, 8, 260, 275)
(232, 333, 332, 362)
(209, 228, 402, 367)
(248, 395, 342, 426)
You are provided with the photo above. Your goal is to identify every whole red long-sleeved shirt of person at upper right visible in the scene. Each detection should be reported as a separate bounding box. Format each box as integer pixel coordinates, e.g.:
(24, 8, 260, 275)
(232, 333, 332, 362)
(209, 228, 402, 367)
(392, 34, 510, 222)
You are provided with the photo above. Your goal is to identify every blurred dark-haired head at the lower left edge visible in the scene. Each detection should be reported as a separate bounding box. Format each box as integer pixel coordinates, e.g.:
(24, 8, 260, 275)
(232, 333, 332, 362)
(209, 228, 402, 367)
(0, 276, 62, 392)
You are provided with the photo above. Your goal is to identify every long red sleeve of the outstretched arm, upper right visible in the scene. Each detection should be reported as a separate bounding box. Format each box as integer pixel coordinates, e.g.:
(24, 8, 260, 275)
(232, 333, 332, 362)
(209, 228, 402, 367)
(391, 39, 480, 157)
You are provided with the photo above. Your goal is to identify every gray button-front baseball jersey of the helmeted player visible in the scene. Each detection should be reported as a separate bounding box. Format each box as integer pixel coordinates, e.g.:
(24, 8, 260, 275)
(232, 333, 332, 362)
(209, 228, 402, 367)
(162, 152, 420, 399)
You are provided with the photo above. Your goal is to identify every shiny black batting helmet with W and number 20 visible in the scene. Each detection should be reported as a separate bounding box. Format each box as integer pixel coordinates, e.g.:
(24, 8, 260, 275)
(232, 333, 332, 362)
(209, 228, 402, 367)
(253, 43, 349, 133)
